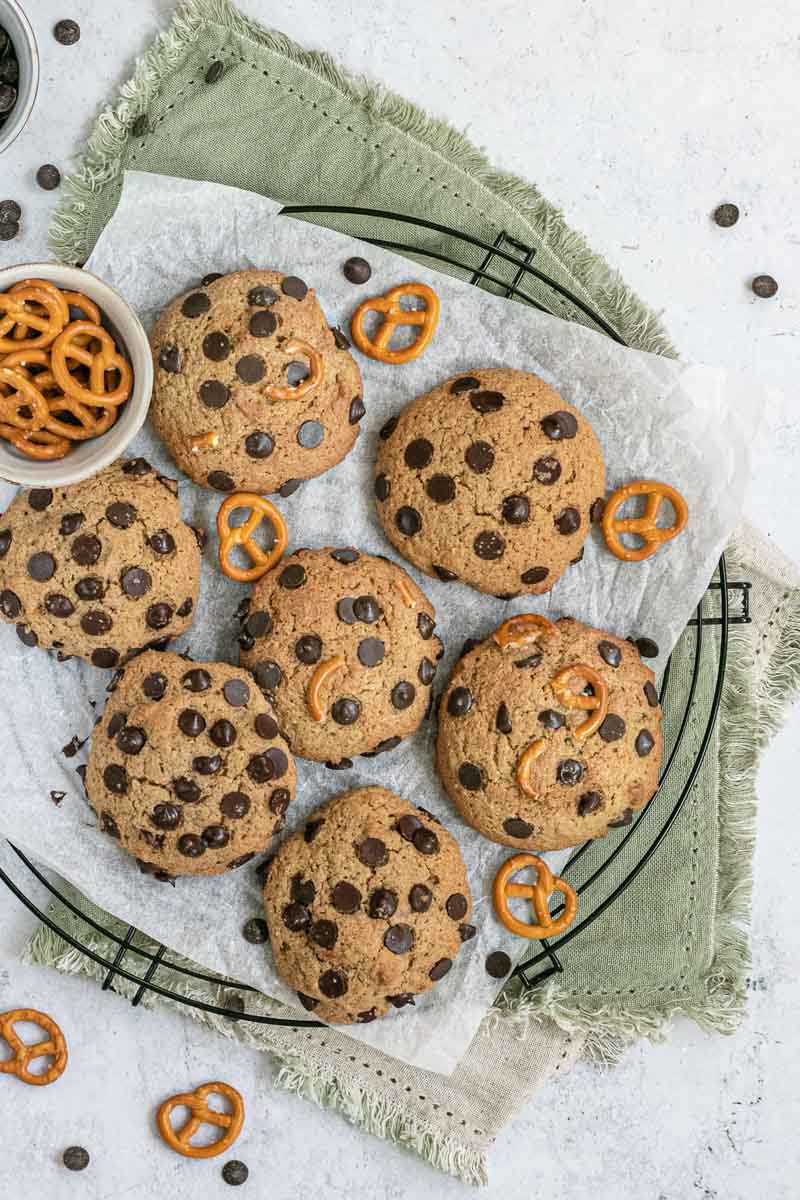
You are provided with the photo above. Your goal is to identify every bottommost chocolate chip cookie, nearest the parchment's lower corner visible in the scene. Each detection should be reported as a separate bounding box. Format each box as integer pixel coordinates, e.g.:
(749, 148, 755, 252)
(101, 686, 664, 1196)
(264, 787, 475, 1025)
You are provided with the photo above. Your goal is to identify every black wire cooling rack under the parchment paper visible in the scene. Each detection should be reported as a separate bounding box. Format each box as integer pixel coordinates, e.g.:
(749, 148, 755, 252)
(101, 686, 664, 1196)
(0, 205, 751, 1028)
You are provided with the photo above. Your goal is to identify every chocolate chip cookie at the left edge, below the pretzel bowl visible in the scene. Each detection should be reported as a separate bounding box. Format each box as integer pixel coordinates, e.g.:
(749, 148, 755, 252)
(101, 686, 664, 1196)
(0, 458, 200, 667)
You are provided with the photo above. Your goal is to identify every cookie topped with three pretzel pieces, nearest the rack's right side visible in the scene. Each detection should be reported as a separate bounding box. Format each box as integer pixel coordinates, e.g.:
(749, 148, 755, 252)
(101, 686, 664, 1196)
(437, 618, 662, 850)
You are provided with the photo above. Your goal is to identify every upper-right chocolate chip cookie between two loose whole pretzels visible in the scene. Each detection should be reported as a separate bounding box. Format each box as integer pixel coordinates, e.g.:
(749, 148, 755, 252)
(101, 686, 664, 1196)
(374, 368, 606, 599)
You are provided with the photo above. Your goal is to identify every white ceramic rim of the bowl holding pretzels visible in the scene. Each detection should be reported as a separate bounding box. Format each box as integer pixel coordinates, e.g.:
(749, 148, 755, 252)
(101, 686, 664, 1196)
(0, 262, 154, 487)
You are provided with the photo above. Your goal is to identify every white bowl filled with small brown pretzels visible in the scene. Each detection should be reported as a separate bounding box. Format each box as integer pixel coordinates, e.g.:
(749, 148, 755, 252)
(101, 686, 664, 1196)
(0, 263, 152, 487)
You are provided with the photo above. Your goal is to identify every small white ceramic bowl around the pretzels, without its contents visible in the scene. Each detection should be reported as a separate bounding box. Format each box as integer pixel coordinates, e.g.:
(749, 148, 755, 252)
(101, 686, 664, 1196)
(0, 263, 152, 487)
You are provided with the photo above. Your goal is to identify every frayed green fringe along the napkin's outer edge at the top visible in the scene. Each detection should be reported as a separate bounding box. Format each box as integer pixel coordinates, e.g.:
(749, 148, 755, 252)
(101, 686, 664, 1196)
(49, 0, 675, 355)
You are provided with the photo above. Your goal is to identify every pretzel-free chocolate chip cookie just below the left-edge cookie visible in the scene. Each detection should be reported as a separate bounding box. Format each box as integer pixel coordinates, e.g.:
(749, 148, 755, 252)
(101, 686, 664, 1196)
(86, 650, 295, 877)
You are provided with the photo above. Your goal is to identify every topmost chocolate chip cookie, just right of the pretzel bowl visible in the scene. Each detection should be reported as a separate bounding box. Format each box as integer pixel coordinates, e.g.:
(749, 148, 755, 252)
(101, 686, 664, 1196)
(150, 271, 365, 496)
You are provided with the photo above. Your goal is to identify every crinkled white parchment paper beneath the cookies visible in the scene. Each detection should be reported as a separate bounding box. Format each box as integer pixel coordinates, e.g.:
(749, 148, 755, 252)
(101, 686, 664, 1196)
(0, 173, 769, 1073)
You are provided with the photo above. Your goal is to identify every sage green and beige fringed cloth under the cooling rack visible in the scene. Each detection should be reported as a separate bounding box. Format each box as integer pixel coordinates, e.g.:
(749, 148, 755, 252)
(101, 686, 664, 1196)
(28, 0, 800, 1183)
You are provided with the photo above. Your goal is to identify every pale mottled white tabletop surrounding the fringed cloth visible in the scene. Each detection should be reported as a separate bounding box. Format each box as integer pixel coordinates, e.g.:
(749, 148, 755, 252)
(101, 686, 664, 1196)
(0, 0, 800, 1200)
